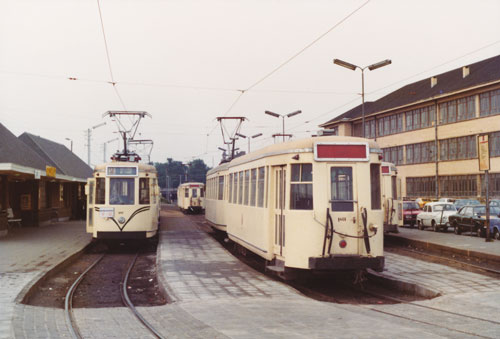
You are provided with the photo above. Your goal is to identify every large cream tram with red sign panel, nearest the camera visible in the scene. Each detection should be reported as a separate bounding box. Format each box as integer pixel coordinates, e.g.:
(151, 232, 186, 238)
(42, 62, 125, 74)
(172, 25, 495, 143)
(206, 136, 384, 273)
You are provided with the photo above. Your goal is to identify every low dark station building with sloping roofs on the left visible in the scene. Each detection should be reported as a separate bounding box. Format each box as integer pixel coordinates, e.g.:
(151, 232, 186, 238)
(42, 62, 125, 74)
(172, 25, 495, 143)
(0, 123, 92, 235)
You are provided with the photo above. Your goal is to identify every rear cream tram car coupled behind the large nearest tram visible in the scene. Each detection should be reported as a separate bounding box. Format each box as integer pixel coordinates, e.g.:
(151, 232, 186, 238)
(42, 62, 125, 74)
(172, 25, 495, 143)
(205, 162, 229, 232)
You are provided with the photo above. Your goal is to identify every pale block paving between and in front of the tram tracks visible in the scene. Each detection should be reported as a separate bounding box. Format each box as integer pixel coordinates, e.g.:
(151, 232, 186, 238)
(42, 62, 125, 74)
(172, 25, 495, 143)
(0, 209, 500, 338)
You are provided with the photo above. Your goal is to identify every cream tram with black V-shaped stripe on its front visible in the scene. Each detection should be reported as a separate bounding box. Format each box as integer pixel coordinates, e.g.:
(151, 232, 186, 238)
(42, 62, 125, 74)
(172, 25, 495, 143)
(85, 161, 160, 239)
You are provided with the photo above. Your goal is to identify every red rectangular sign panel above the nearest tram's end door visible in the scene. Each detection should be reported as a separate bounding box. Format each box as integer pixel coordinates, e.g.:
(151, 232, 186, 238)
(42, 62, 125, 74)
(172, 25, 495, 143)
(314, 142, 370, 161)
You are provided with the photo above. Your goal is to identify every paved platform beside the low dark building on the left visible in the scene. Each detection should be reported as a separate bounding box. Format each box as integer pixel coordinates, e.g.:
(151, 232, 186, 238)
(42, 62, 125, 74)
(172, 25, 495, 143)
(0, 221, 91, 338)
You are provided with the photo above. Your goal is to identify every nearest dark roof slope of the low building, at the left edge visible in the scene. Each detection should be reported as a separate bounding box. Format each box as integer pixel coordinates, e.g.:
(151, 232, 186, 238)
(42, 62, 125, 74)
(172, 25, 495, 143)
(0, 123, 50, 170)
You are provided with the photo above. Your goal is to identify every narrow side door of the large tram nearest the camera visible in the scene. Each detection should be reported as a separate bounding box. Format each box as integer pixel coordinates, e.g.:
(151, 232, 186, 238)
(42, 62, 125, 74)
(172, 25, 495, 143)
(273, 165, 286, 256)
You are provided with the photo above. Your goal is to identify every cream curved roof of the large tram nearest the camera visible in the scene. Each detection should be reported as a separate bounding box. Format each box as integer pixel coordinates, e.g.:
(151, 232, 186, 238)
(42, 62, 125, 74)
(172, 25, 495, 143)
(207, 135, 379, 175)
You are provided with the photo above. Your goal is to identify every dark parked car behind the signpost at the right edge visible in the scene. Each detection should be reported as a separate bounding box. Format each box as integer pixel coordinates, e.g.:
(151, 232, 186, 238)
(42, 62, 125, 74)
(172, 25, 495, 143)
(449, 205, 500, 239)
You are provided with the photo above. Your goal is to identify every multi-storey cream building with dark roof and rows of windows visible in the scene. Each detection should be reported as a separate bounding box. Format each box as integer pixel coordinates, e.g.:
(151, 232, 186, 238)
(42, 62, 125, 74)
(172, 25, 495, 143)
(320, 55, 500, 198)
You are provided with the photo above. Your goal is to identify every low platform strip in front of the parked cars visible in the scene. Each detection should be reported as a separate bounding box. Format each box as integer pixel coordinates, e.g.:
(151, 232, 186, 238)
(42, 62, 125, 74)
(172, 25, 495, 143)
(386, 227, 500, 269)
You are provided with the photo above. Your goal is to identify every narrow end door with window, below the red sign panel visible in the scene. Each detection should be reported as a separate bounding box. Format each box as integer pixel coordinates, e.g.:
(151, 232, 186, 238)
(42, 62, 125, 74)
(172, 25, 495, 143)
(329, 166, 360, 254)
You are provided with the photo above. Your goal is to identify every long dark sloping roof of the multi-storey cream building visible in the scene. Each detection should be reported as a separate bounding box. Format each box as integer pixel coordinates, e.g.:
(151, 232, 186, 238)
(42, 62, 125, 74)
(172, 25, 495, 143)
(320, 55, 500, 127)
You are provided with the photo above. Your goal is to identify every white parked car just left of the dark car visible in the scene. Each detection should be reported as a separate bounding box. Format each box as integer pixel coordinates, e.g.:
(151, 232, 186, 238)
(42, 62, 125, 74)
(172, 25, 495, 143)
(417, 202, 457, 232)
